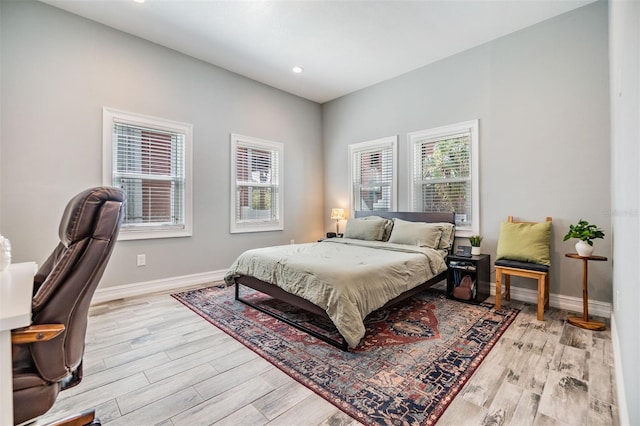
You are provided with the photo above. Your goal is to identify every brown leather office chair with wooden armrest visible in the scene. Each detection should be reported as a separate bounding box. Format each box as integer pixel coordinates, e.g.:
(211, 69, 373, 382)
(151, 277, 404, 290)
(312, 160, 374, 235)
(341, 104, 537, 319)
(12, 187, 125, 424)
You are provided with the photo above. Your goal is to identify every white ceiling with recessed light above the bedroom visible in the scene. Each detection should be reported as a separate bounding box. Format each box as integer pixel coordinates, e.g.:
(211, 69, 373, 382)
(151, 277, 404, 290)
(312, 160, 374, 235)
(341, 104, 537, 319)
(41, 0, 594, 103)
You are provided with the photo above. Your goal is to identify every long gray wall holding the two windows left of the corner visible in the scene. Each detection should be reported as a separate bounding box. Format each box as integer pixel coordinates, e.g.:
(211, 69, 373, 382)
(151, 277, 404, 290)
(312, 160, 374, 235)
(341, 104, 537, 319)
(0, 1, 324, 287)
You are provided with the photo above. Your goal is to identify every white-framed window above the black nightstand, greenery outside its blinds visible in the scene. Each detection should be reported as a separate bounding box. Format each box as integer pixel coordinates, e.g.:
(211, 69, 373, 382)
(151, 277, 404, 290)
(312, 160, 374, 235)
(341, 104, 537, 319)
(408, 120, 480, 236)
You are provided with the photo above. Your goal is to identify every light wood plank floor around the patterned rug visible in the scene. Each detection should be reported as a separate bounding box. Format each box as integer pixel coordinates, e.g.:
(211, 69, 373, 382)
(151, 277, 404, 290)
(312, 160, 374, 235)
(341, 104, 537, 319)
(37, 284, 619, 426)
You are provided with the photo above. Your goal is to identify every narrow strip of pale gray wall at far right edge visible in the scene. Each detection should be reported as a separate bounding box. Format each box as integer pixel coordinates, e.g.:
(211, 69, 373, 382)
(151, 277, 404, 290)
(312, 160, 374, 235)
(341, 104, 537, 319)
(609, 1, 640, 425)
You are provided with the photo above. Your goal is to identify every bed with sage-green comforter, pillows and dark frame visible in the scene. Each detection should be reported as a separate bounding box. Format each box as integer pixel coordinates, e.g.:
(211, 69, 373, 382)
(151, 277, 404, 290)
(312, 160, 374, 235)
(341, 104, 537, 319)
(225, 212, 455, 350)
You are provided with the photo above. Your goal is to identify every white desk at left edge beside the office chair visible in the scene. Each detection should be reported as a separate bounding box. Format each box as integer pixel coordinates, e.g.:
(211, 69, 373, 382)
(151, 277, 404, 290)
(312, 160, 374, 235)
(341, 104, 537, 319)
(0, 262, 36, 426)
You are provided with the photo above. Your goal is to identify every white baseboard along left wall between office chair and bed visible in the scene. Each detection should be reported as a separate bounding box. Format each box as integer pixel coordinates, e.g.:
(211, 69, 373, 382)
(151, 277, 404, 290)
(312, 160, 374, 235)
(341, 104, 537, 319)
(91, 269, 227, 305)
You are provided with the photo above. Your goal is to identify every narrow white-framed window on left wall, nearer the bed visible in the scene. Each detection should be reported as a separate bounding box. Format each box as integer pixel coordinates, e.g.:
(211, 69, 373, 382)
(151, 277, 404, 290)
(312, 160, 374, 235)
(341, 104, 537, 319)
(231, 134, 284, 233)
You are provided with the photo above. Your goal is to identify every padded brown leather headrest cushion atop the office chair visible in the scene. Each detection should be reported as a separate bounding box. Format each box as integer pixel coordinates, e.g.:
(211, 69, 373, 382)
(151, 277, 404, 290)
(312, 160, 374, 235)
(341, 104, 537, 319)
(58, 186, 126, 247)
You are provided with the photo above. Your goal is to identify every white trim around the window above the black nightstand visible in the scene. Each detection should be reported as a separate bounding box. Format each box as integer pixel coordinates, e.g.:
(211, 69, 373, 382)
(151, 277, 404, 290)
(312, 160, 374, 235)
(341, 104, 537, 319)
(407, 119, 480, 237)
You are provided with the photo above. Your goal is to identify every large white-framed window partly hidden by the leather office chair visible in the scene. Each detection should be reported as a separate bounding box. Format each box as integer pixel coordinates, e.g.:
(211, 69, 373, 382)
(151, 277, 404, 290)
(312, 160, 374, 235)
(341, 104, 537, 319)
(102, 108, 192, 240)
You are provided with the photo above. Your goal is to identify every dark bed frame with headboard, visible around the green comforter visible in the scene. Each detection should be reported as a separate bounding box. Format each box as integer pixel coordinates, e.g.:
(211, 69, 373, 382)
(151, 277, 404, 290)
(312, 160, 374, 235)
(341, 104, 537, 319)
(235, 211, 455, 351)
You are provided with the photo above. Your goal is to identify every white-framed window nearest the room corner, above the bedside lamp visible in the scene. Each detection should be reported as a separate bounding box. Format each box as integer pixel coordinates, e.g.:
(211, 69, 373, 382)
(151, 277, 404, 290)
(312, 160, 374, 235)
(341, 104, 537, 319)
(349, 136, 398, 217)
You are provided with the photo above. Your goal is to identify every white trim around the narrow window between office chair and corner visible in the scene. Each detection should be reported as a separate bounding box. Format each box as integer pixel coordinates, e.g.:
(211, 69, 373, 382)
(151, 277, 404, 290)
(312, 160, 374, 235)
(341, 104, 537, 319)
(229, 133, 284, 234)
